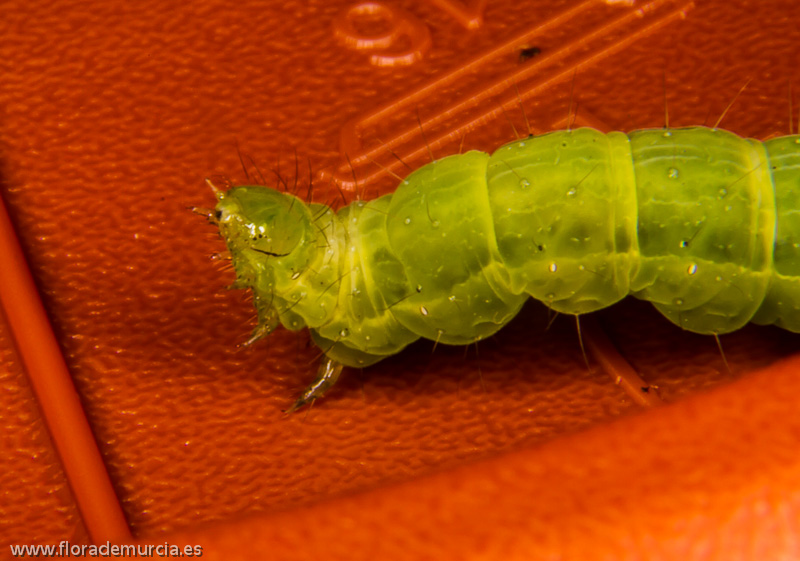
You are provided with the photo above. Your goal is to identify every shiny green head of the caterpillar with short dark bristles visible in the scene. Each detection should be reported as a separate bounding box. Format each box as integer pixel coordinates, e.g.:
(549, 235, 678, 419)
(208, 186, 316, 343)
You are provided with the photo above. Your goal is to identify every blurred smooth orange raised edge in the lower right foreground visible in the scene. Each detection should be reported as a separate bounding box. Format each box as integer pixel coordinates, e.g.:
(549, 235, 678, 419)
(145, 359, 800, 561)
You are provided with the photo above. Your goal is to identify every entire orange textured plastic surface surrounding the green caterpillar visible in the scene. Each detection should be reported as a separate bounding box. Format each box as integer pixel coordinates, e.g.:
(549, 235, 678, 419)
(0, 0, 800, 561)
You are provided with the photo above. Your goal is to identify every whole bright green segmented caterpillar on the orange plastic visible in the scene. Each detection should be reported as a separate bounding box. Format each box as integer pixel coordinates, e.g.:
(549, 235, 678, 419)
(208, 127, 800, 411)
